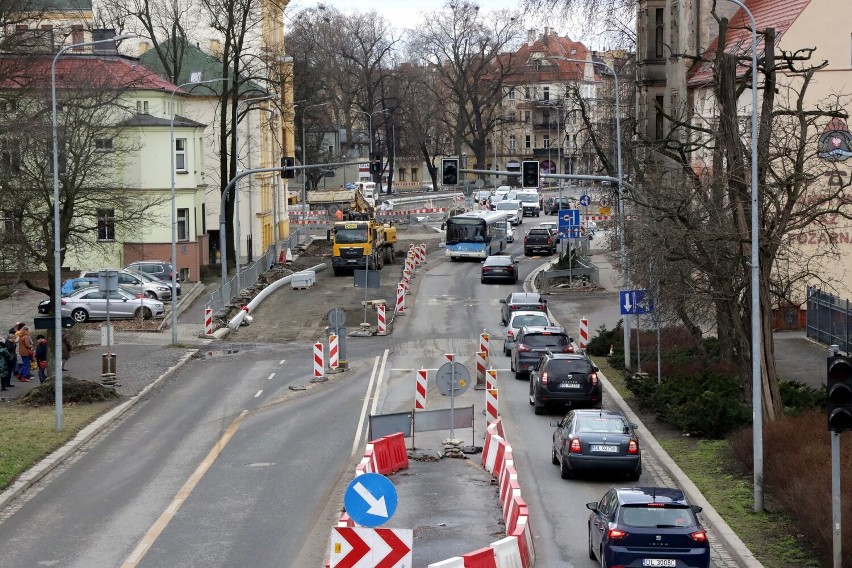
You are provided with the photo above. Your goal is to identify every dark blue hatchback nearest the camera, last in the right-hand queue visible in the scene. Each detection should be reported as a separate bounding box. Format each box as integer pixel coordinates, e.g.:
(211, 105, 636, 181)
(586, 487, 710, 568)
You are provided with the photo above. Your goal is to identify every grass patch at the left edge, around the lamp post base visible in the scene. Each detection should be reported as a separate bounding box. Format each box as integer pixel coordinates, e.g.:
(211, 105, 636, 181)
(0, 401, 118, 490)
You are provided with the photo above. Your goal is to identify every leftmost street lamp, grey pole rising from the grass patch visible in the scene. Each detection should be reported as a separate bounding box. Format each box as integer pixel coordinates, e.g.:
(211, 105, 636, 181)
(50, 35, 136, 432)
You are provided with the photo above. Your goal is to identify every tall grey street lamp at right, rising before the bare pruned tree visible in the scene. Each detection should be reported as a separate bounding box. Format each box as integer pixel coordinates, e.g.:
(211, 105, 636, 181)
(730, 0, 764, 513)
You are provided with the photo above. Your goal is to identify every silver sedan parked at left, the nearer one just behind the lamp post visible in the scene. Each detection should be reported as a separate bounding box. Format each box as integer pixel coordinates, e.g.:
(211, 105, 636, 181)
(62, 286, 166, 323)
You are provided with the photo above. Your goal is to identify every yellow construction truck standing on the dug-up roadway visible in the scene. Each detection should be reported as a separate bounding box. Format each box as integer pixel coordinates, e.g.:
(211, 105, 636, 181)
(329, 190, 396, 276)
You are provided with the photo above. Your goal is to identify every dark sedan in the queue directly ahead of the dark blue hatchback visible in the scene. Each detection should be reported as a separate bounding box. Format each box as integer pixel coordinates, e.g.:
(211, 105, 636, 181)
(550, 410, 642, 481)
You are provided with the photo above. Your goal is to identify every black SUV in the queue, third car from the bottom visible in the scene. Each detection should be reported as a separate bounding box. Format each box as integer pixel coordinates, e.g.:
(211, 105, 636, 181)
(532, 350, 603, 414)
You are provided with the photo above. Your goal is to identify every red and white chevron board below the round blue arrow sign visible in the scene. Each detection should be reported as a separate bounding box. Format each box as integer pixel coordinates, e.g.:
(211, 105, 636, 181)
(329, 527, 414, 568)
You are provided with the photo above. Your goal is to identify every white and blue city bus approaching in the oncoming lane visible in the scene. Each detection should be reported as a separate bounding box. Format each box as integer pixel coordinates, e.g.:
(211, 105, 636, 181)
(446, 211, 506, 260)
